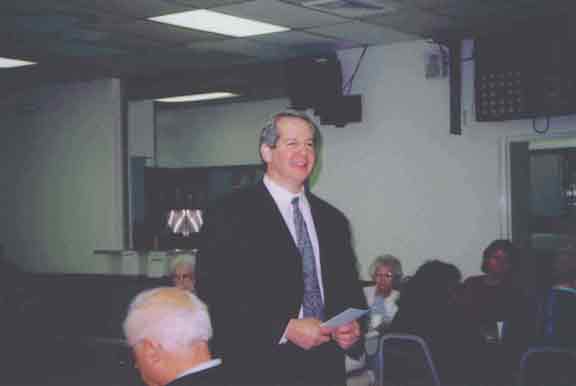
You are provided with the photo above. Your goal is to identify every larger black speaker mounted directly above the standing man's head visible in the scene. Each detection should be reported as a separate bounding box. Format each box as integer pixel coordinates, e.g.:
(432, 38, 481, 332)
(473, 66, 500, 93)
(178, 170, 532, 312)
(285, 54, 342, 110)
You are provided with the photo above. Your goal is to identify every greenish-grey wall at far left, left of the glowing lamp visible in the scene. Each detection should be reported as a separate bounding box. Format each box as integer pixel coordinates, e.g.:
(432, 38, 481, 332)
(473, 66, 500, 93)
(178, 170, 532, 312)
(0, 80, 122, 272)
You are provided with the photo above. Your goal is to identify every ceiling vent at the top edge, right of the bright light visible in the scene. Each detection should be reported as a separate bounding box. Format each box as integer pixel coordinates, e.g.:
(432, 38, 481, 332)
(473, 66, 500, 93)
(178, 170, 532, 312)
(302, 0, 400, 17)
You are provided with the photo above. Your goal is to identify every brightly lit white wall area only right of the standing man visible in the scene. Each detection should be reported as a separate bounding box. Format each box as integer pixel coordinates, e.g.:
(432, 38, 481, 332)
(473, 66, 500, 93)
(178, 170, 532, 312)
(324, 42, 500, 275)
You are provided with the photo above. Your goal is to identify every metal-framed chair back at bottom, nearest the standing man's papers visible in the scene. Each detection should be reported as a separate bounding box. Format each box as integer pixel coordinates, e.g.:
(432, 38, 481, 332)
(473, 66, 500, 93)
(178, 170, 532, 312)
(376, 333, 441, 386)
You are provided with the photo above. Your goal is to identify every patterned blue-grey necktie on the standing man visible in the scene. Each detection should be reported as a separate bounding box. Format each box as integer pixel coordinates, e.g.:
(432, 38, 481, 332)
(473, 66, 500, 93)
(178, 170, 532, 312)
(292, 197, 324, 320)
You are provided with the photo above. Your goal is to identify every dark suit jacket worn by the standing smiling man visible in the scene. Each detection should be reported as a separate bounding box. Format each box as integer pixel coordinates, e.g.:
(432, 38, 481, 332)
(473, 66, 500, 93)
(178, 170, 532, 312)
(197, 182, 365, 384)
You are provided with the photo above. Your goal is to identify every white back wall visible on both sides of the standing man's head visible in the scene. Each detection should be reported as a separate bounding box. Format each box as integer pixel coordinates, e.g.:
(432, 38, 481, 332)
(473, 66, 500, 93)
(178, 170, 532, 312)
(157, 41, 576, 275)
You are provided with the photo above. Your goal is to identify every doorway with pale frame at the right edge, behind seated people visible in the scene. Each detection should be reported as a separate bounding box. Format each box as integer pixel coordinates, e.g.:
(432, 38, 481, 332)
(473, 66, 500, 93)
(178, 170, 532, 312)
(508, 138, 576, 286)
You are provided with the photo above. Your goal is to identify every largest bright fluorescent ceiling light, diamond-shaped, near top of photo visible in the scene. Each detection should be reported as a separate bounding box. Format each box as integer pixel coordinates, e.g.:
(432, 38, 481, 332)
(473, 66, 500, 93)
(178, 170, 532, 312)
(149, 9, 289, 37)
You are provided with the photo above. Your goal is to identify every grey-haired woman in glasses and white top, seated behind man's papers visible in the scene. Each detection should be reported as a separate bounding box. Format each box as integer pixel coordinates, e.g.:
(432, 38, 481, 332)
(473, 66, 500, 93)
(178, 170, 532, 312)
(364, 255, 402, 328)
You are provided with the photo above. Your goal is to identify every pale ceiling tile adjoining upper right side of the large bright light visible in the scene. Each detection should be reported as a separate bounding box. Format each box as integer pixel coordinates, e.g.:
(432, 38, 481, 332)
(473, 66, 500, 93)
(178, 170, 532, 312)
(215, 0, 346, 28)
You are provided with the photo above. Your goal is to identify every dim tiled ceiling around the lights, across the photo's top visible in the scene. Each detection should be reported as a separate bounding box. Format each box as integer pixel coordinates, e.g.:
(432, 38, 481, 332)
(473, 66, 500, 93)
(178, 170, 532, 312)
(0, 0, 576, 96)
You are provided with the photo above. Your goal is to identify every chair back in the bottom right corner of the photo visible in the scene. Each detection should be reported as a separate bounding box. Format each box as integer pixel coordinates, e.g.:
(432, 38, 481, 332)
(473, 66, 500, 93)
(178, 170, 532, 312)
(518, 346, 576, 386)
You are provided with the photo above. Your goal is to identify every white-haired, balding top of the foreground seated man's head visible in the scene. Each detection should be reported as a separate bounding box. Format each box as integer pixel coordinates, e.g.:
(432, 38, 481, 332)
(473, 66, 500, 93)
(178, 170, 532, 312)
(123, 287, 212, 351)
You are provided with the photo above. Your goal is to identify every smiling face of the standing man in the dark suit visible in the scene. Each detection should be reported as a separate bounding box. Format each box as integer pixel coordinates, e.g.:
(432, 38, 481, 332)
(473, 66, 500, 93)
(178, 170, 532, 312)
(260, 117, 316, 193)
